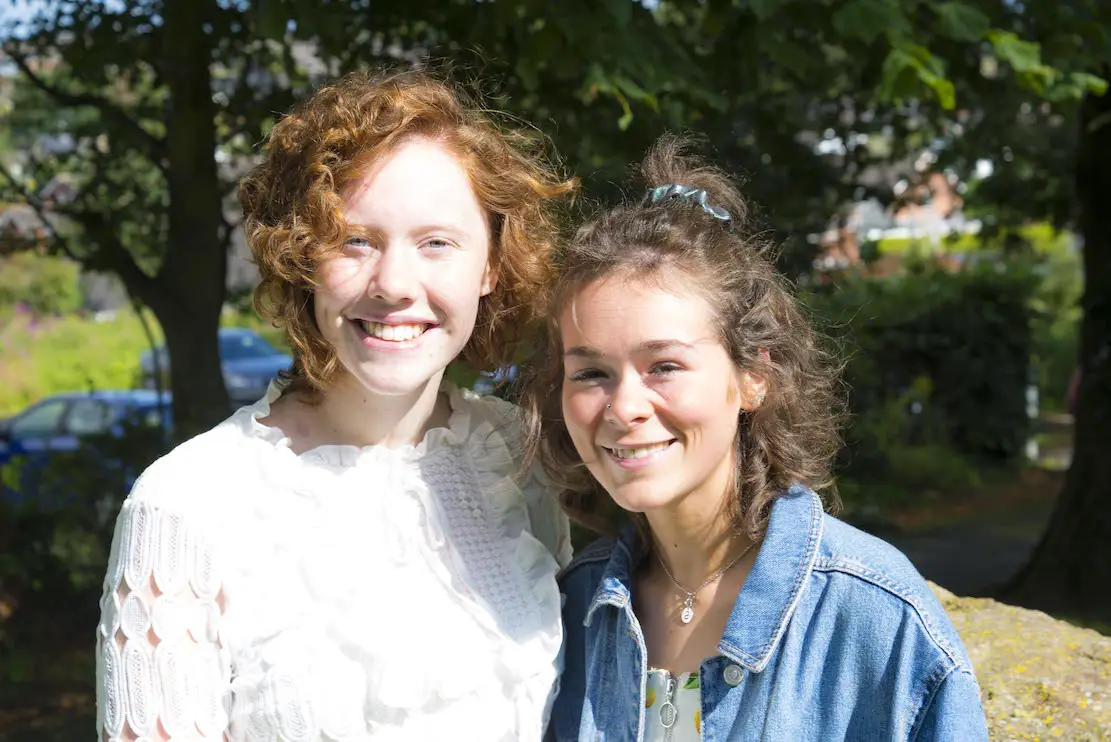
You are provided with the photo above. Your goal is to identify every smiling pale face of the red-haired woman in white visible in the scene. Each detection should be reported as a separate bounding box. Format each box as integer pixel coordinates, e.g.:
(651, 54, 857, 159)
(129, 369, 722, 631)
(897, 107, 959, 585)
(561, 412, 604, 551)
(313, 139, 496, 395)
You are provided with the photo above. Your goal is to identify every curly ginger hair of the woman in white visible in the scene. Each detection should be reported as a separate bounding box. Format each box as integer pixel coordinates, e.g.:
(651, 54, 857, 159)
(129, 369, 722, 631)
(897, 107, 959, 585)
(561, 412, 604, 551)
(239, 70, 575, 391)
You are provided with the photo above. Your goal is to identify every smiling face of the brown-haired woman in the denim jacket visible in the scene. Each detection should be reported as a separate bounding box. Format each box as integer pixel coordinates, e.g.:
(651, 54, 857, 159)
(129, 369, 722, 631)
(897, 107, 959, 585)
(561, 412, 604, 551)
(560, 277, 759, 513)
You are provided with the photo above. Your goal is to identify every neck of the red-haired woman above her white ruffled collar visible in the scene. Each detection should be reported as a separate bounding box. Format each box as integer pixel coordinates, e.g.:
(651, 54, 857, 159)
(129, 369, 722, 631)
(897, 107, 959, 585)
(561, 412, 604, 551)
(306, 371, 451, 448)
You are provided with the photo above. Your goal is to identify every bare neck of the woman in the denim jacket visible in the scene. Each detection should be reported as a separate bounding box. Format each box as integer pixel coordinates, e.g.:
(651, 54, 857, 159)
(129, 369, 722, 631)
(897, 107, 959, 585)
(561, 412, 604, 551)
(645, 461, 752, 591)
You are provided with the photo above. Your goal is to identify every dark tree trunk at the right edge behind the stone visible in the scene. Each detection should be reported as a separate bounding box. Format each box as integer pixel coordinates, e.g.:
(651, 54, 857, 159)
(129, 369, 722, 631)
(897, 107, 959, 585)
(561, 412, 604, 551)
(1003, 75, 1111, 620)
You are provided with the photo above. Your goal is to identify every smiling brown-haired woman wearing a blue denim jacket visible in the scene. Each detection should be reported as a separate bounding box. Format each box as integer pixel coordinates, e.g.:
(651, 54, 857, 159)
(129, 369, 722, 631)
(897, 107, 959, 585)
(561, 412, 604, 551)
(526, 139, 987, 742)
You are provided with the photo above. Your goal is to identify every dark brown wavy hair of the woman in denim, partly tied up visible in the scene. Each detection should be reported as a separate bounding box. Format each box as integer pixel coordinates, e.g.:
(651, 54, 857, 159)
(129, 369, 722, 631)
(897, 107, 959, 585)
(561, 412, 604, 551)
(521, 136, 843, 539)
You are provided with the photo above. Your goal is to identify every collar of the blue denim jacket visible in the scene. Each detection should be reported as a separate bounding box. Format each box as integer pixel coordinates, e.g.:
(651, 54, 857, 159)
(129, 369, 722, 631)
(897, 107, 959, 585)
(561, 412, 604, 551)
(583, 485, 823, 672)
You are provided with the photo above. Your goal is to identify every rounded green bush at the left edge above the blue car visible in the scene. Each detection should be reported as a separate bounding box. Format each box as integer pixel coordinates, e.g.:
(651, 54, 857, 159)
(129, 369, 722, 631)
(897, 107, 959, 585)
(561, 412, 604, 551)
(0, 252, 82, 315)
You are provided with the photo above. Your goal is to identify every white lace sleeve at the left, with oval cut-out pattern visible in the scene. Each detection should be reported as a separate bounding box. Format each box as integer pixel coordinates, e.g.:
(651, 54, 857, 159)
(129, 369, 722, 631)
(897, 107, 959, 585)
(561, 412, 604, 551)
(97, 499, 231, 742)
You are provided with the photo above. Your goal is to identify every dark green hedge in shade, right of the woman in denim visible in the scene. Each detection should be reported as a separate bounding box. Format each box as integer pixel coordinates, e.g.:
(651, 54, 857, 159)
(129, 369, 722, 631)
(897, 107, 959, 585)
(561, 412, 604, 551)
(803, 241, 1081, 505)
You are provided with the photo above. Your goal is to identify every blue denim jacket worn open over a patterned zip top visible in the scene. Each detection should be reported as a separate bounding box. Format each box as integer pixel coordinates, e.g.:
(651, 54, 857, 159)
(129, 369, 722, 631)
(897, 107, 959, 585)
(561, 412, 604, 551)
(549, 487, 988, 742)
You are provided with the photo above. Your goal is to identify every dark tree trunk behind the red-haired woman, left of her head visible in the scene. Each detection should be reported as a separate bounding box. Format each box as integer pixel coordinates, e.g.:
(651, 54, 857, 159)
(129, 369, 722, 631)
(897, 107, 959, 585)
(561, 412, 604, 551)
(157, 0, 229, 440)
